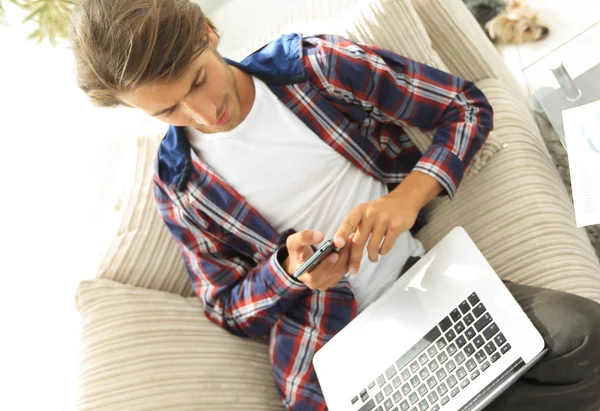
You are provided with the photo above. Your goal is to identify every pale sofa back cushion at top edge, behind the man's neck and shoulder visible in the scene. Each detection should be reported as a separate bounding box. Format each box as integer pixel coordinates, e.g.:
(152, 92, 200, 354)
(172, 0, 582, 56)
(210, 0, 445, 69)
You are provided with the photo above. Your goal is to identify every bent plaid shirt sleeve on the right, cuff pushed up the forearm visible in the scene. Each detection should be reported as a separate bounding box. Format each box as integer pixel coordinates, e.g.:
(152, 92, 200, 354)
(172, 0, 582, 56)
(304, 35, 493, 197)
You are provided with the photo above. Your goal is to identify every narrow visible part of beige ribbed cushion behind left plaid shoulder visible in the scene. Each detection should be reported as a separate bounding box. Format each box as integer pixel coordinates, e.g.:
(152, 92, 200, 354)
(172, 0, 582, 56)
(97, 137, 193, 296)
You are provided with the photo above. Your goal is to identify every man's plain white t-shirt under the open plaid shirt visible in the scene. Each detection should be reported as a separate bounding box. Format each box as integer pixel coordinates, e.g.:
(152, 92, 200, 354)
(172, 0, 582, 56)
(188, 77, 424, 310)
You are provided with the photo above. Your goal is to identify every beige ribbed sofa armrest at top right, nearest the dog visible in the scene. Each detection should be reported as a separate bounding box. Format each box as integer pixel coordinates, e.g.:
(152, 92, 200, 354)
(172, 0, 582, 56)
(413, 0, 525, 98)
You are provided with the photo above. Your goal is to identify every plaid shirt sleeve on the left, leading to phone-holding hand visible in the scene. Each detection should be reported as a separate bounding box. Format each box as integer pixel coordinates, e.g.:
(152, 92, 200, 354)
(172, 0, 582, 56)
(154, 177, 309, 337)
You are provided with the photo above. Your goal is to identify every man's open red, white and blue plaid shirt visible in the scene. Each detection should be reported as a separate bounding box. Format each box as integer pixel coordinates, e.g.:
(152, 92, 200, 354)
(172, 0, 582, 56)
(154, 34, 492, 410)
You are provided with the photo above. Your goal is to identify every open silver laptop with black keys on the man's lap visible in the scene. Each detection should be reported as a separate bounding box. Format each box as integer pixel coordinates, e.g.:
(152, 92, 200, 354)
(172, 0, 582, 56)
(313, 227, 547, 411)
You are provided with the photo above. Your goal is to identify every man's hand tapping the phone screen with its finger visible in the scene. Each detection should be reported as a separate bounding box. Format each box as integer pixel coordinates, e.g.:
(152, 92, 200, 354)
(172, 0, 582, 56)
(334, 194, 419, 274)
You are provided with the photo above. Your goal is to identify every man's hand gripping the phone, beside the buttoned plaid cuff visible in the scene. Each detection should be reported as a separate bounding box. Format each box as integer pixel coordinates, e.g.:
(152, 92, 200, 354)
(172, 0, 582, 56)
(283, 230, 352, 291)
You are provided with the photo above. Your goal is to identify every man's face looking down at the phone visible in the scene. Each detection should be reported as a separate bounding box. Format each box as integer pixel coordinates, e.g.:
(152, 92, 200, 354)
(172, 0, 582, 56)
(119, 32, 243, 133)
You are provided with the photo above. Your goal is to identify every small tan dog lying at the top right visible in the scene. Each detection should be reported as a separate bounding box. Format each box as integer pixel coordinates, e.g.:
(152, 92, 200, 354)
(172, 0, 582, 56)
(463, 0, 550, 44)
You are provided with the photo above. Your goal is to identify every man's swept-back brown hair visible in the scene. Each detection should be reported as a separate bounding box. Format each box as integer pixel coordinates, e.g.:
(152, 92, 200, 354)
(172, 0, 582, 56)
(69, 0, 216, 107)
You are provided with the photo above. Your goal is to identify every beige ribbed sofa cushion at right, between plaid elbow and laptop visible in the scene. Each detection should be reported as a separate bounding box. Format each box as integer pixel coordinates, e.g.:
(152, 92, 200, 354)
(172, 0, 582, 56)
(418, 79, 600, 302)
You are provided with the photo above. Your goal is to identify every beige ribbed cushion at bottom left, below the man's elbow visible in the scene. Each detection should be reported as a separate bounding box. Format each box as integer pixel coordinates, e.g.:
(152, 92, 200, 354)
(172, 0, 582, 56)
(77, 280, 283, 411)
